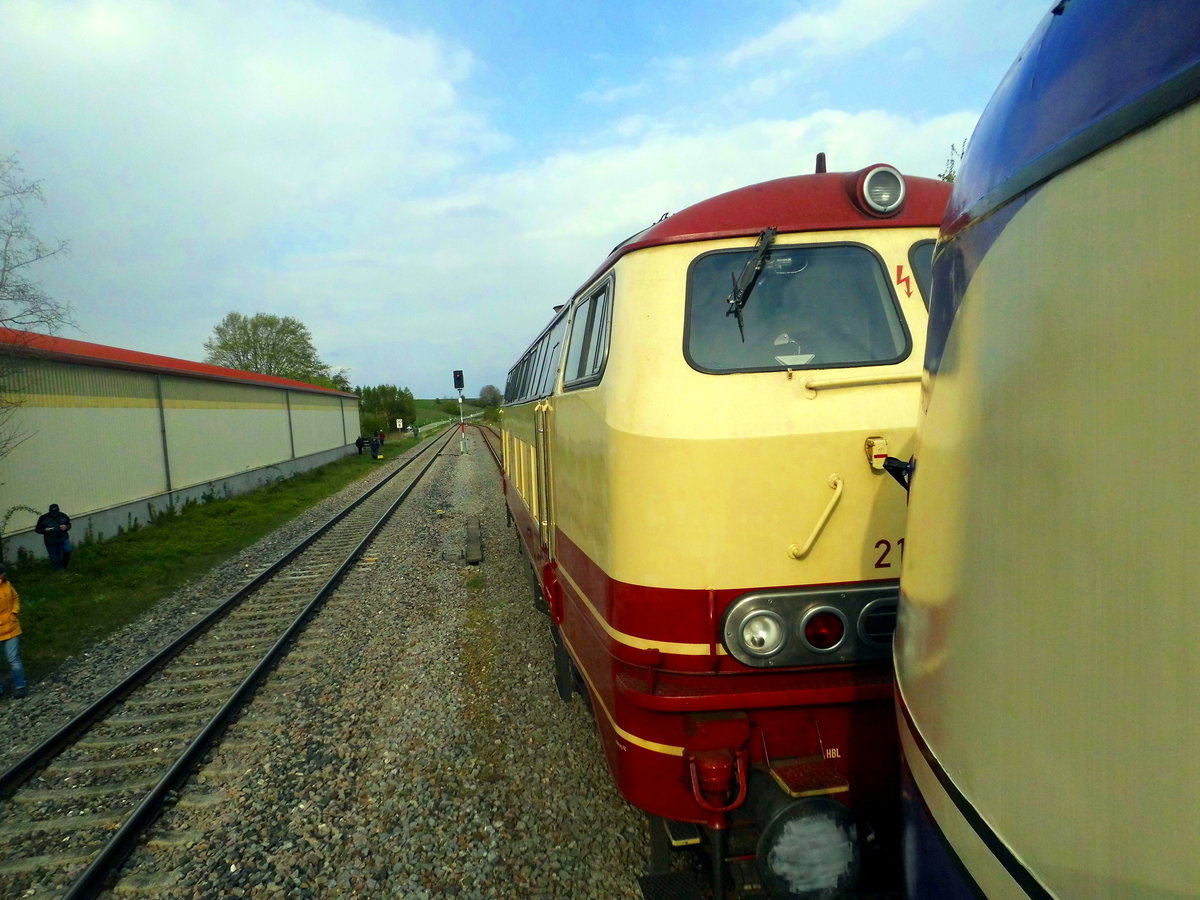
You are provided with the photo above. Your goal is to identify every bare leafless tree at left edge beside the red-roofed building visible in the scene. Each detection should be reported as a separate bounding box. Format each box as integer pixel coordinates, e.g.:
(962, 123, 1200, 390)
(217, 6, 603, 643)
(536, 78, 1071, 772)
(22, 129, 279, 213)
(0, 154, 74, 456)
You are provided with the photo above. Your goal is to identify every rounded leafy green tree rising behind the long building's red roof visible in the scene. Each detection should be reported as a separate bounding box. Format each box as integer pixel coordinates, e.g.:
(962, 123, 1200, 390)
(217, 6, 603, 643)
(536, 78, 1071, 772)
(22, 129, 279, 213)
(204, 312, 344, 383)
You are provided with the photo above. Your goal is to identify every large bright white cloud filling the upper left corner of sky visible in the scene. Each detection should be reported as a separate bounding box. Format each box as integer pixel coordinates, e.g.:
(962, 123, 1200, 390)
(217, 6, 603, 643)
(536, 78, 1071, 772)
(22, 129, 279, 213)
(0, 0, 505, 239)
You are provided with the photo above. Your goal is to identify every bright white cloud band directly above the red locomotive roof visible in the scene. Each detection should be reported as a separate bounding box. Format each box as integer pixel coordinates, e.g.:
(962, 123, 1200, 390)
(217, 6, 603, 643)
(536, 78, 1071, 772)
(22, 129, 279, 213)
(367, 110, 976, 367)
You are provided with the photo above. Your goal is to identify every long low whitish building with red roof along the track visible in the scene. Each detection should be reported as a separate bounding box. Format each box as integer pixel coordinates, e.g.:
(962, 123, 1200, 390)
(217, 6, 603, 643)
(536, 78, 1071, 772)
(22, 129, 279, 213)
(0, 329, 359, 559)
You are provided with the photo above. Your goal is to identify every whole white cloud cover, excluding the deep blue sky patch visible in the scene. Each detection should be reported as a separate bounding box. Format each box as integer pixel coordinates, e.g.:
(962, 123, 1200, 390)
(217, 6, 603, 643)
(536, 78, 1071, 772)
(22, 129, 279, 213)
(0, 0, 1003, 396)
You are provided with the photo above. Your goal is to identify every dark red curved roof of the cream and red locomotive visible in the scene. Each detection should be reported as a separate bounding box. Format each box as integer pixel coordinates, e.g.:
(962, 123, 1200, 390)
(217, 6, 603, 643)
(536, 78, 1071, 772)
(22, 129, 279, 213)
(576, 167, 953, 295)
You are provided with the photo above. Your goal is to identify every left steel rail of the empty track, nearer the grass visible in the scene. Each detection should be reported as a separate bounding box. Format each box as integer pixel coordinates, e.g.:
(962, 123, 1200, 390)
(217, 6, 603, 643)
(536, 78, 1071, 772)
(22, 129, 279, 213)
(0, 439, 449, 797)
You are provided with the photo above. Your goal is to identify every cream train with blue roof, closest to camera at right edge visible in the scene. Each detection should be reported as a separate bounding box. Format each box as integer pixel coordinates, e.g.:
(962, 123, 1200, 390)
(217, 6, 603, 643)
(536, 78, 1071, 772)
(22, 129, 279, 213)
(896, 0, 1200, 900)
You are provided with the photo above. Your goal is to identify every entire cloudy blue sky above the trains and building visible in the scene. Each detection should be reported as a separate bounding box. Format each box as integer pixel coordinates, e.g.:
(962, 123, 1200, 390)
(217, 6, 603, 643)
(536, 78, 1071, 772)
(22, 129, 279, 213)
(0, 0, 1052, 397)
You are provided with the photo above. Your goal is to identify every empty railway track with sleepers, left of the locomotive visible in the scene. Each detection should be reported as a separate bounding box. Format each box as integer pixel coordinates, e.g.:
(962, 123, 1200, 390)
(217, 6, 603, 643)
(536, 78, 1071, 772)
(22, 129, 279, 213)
(0, 431, 454, 898)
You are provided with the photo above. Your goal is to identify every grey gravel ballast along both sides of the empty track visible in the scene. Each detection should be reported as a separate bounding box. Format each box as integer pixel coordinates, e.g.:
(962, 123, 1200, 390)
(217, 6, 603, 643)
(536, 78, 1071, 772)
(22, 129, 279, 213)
(0, 433, 648, 899)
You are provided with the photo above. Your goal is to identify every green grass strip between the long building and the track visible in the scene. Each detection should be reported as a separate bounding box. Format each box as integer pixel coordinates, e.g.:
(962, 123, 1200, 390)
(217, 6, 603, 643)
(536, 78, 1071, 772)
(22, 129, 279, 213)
(8, 437, 422, 680)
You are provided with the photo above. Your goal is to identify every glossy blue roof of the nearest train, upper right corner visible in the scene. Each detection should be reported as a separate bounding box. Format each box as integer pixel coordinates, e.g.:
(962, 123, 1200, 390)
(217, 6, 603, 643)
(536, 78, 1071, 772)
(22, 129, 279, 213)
(943, 0, 1200, 232)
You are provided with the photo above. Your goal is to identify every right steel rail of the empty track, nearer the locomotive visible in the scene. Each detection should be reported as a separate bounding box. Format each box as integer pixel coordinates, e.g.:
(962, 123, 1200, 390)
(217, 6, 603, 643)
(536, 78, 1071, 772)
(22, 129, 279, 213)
(62, 431, 454, 900)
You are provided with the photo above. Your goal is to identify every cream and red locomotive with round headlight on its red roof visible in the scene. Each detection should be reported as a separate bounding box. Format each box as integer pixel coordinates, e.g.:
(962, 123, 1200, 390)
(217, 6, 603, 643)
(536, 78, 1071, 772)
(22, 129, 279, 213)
(502, 167, 949, 896)
